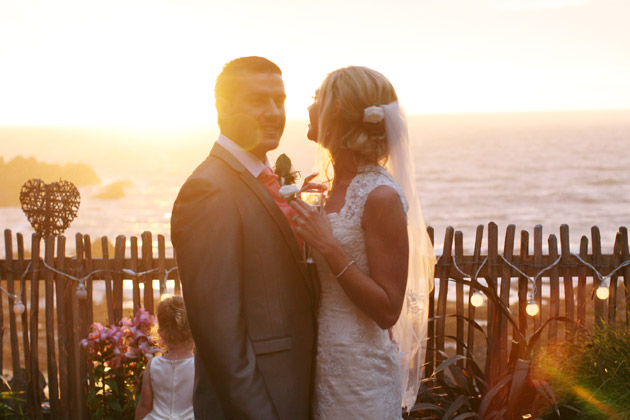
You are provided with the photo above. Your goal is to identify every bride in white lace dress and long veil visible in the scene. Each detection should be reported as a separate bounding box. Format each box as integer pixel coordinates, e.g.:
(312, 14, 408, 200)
(290, 67, 434, 420)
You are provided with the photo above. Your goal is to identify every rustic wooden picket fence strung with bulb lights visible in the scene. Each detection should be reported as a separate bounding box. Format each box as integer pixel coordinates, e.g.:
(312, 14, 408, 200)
(0, 223, 630, 419)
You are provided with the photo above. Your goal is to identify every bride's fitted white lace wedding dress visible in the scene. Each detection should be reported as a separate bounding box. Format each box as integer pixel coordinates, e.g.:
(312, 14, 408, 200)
(313, 165, 407, 420)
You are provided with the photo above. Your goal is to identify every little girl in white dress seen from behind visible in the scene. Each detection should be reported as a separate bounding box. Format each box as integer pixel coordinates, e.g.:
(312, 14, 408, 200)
(135, 296, 195, 420)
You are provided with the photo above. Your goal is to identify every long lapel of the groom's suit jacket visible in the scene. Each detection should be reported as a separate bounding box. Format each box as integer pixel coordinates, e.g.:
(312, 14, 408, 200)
(210, 143, 313, 292)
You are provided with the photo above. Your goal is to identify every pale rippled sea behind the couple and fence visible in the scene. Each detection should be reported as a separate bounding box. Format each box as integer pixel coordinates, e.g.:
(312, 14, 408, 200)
(0, 110, 630, 257)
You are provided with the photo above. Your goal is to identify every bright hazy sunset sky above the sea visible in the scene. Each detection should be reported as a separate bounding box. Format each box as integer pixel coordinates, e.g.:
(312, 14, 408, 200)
(0, 0, 630, 128)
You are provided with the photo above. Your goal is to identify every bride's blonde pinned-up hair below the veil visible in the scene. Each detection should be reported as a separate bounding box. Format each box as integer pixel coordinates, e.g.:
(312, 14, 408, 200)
(316, 66, 398, 164)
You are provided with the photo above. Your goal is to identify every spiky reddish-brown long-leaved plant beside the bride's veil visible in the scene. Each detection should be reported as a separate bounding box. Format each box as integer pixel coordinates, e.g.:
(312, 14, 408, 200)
(408, 270, 570, 420)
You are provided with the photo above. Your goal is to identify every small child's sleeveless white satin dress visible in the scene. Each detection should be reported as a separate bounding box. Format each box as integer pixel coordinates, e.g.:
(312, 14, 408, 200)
(144, 356, 195, 420)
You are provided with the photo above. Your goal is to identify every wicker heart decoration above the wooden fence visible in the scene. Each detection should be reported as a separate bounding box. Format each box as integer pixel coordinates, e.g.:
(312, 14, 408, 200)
(20, 179, 81, 237)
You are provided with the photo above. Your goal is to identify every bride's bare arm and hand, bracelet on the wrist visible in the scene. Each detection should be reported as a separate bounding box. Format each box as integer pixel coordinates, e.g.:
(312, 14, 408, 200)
(291, 186, 409, 329)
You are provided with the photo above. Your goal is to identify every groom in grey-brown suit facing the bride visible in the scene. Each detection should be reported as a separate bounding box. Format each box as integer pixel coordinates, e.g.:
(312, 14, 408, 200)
(171, 57, 316, 420)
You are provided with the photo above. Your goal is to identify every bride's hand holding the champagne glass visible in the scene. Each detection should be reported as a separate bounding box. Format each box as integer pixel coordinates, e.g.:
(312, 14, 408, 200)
(289, 198, 336, 251)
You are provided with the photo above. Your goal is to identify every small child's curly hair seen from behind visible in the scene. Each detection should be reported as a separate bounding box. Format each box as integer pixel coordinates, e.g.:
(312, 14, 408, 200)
(157, 296, 192, 350)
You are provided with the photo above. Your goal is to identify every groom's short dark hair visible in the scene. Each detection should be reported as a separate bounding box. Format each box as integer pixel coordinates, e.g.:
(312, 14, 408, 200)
(214, 56, 282, 101)
